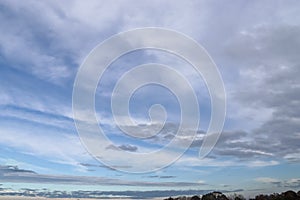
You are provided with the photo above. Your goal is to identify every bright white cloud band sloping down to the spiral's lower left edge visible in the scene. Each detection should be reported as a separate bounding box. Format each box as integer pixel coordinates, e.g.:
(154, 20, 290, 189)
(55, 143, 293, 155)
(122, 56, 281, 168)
(0, 123, 91, 167)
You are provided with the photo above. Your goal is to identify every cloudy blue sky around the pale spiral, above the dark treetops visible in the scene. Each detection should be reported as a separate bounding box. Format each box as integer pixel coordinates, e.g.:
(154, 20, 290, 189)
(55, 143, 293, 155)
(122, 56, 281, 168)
(0, 0, 300, 198)
